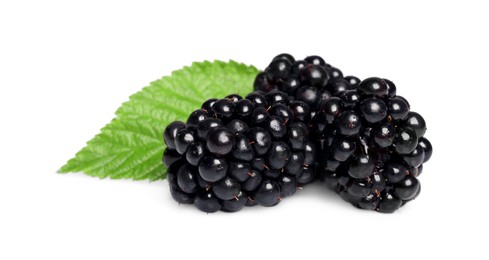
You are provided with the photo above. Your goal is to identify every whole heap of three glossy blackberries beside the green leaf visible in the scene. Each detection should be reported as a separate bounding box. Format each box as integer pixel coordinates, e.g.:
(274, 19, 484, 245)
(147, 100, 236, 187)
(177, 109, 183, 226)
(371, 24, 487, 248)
(164, 54, 432, 213)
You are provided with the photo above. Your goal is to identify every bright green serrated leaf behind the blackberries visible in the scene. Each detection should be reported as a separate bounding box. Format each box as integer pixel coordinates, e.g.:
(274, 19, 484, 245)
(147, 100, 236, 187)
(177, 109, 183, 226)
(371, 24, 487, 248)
(58, 61, 258, 180)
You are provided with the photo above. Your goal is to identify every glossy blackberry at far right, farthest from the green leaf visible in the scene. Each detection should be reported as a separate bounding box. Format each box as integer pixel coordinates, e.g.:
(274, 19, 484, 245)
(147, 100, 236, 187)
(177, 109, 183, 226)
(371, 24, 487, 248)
(313, 78, 432, 213)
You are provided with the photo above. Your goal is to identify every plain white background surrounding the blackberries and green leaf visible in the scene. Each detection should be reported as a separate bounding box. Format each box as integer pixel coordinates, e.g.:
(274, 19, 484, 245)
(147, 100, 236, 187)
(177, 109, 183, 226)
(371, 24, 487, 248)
(0, 0, 489, 259)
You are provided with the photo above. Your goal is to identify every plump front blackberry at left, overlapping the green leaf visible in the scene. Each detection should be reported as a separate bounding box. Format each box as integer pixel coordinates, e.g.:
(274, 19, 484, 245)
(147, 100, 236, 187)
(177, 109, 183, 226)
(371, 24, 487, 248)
(163, 90, 316, 213)
